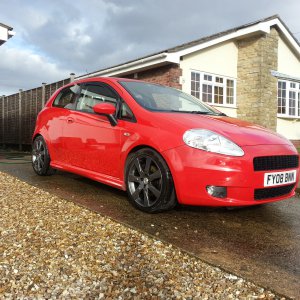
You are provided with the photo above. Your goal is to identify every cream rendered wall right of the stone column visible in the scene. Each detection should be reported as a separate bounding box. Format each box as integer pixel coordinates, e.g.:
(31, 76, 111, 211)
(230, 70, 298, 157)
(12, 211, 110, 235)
(277, 37, 300, 140)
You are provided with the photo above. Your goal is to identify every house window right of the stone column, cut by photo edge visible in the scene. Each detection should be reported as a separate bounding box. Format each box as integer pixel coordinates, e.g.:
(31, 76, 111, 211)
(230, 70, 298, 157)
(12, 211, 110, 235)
(277, 80, 300, 118)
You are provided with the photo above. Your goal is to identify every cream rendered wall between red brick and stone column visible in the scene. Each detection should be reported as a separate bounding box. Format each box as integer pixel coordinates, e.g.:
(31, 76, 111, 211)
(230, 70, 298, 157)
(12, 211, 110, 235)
(180, 42, 238, 117)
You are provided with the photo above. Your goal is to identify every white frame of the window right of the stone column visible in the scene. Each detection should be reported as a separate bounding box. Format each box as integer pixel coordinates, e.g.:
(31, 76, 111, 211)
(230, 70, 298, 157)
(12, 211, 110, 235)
(277, 79, 300, 119)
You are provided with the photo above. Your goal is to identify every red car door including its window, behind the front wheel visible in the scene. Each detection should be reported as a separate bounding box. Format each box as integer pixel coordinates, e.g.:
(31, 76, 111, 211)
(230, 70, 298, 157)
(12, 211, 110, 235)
(63, 82, 123, 178)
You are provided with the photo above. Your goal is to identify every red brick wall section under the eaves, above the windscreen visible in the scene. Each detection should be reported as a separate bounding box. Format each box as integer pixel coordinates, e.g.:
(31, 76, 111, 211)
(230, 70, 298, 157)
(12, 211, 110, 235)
(122, 64, 182, 89)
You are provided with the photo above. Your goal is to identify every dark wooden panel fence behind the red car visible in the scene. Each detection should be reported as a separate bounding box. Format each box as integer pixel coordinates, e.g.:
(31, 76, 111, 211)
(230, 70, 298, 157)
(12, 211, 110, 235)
(0, 78, 70, 145)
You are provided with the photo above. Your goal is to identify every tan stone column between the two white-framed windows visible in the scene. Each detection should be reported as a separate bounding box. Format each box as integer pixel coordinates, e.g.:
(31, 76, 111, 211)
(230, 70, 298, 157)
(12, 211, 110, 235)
(237, 28, 278, 131)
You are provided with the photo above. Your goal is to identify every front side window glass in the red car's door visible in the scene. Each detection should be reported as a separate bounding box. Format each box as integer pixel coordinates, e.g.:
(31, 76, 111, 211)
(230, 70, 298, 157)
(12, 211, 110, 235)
(76, 84, 119, 113)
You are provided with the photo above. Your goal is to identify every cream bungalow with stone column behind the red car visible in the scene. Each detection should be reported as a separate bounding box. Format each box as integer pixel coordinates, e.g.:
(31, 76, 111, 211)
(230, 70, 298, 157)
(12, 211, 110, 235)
(76, 15, 300, 145)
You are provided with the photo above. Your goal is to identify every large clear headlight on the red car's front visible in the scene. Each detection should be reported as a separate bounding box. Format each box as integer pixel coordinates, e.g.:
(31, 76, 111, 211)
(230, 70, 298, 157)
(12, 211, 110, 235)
(183, 129, 244, 156)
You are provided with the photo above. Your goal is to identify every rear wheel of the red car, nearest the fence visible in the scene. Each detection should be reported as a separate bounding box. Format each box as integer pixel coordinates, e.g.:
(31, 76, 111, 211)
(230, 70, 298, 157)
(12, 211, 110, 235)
(31, 135, 55, 176)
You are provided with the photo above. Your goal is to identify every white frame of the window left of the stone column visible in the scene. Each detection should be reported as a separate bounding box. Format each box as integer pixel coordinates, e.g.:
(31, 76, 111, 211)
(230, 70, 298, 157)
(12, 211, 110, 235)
(189, 69, 237, 108)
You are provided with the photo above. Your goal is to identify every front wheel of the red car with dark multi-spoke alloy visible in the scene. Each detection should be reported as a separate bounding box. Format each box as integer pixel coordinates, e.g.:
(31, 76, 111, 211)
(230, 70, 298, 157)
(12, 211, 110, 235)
(125, 148, 177, 213)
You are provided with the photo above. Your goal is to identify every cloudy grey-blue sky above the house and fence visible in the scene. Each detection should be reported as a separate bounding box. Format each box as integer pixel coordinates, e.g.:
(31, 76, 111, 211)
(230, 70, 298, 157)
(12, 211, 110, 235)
(0, 0, 300, 95)
